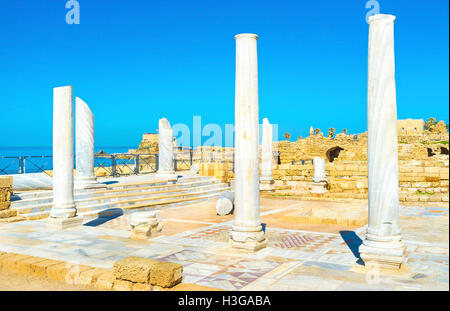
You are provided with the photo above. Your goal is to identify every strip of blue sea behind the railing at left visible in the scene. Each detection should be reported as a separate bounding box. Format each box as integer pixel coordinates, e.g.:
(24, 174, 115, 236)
(0, 146, 136, 175)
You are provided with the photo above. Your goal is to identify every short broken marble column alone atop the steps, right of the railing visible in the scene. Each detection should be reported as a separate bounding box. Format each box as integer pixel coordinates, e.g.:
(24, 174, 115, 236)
(158, 118, 177, 181)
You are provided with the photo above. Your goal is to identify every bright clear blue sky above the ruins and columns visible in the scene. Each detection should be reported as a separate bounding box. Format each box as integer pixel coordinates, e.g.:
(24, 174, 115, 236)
(0, 0, 449, 147)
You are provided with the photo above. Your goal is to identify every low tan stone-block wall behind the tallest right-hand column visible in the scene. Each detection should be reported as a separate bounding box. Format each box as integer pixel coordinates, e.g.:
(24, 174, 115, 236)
(273, 159, 449, 202)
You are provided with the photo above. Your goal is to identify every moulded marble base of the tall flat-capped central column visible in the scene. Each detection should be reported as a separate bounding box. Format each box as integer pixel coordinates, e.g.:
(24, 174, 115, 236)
(229, 226, 267, 252)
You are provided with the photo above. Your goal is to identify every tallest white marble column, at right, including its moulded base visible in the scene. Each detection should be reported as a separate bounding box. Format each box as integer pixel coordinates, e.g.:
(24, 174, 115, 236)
(359, 14, 405, 269)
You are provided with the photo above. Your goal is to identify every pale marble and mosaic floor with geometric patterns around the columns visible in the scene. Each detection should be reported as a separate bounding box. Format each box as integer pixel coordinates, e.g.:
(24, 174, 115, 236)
(0, 199, 449, 291)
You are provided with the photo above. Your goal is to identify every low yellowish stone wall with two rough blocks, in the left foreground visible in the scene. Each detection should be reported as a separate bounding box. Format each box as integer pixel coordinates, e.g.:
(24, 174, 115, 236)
(0, 251, 194, 291)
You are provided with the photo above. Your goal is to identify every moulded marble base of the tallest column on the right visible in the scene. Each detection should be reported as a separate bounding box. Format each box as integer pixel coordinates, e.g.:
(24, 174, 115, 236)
(359, 234, 406, 270)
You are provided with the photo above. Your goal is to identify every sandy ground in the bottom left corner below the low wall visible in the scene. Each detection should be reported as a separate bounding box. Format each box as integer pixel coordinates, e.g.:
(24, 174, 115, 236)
(0, 272, 104, 291)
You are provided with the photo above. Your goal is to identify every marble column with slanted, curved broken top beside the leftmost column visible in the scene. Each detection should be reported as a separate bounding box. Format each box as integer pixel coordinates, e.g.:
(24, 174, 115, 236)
(75, 97, 106, 189)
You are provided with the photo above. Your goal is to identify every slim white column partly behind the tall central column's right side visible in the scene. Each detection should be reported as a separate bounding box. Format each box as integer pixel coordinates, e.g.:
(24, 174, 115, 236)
(260, 118, 275, 191)
